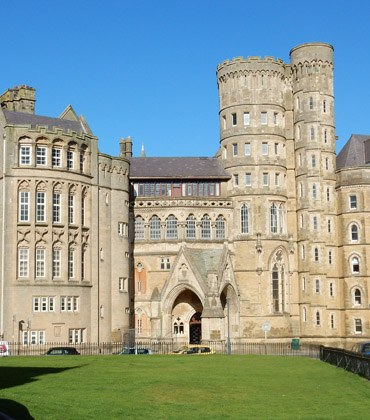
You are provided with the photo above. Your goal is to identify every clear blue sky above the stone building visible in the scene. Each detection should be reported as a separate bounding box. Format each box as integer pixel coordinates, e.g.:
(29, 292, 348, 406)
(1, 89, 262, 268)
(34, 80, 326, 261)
(0, 0, 370, 156)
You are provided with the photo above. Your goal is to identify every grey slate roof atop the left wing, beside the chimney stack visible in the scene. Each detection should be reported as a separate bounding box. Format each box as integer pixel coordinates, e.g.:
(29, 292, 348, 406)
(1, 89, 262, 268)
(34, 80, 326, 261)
(3, 109, 87, 133)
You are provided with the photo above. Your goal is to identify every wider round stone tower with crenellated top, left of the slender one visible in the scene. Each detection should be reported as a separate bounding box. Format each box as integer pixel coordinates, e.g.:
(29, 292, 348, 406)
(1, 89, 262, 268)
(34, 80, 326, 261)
(217, 57, 294, 326)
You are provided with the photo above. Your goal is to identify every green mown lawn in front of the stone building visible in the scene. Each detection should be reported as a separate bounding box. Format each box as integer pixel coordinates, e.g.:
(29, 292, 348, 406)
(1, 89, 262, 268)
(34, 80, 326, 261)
(0, 355, 370, 420)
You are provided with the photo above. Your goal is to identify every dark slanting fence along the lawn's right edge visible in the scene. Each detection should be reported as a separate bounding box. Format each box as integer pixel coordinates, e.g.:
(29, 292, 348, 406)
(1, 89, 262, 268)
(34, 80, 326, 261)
(320, 346, 370, 379)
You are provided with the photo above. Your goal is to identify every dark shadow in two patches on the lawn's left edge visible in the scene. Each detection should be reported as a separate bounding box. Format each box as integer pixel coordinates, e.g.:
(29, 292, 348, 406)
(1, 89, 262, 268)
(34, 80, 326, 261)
(0, 366, 81, 420)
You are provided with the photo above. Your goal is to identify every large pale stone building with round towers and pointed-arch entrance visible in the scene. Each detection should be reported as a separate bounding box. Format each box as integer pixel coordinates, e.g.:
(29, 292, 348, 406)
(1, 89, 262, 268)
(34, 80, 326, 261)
(0, 43, 370, 347)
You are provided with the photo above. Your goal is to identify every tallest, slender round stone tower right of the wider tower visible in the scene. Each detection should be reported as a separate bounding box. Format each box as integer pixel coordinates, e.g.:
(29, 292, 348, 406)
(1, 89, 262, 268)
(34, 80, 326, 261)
(290, 43, 338, 333)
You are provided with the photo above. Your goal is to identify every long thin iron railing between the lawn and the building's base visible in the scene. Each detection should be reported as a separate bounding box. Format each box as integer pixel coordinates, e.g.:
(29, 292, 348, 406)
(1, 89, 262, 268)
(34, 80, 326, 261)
(2, 340, 320, 358)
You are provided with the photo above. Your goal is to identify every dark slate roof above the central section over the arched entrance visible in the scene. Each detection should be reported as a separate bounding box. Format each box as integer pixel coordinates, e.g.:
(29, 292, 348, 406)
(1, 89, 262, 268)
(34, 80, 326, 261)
(130, 157, 230, 179)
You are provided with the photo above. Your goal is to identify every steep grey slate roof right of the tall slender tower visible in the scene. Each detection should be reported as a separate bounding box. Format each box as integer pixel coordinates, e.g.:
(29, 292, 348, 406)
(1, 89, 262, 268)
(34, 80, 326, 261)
(337, 134, 370, 169)
